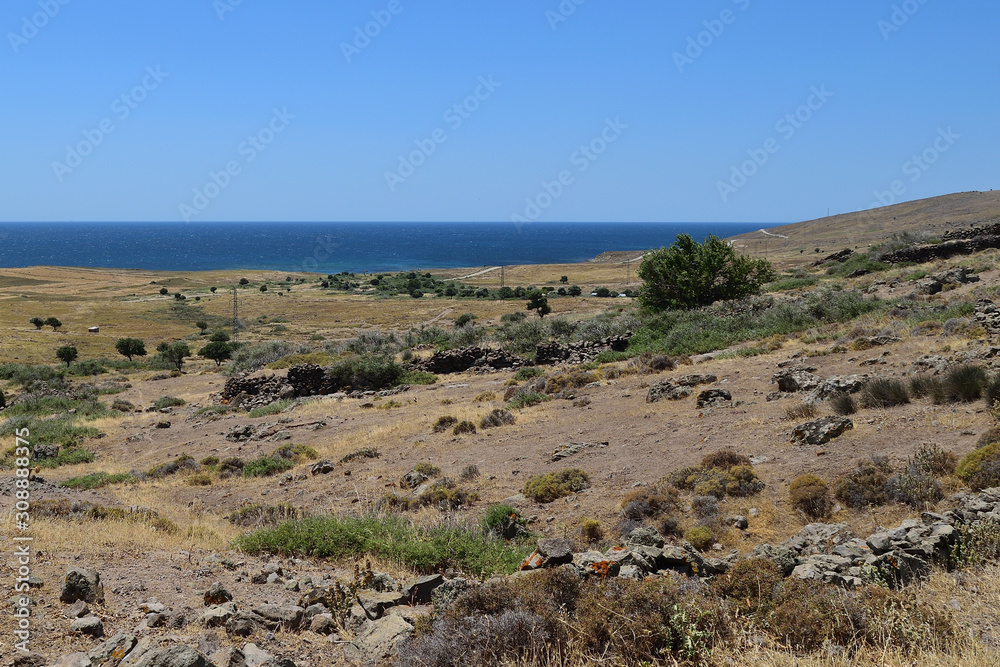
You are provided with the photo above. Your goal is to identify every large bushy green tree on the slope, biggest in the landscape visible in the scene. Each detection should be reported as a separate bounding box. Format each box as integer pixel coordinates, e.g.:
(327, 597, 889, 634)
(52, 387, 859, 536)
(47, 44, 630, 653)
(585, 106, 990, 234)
(639, 234, 774, 310)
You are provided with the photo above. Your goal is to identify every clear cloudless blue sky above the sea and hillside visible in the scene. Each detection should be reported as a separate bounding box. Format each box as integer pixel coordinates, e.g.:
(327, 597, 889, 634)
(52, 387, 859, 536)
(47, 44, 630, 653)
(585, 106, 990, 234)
(0, 0, 1000, 223)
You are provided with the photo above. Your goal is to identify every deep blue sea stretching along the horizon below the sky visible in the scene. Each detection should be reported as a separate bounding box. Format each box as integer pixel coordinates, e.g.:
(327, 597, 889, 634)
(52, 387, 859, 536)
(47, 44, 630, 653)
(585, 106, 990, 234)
(0, 222, 773, 273)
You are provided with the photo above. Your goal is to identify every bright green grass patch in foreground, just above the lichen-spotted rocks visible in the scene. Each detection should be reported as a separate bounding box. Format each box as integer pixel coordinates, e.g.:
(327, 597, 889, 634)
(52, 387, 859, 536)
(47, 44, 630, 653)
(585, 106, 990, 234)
(235, 515, 531, 576)
